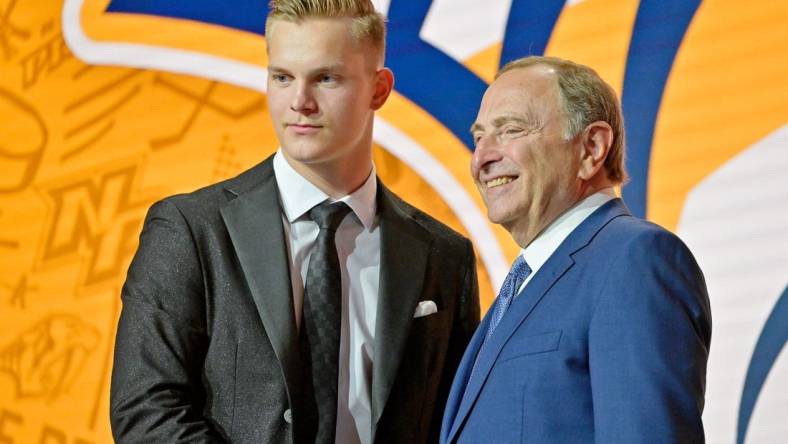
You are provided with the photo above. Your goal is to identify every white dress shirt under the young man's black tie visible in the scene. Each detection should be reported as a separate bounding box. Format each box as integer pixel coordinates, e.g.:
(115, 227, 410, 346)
(274, 150, 380, 444)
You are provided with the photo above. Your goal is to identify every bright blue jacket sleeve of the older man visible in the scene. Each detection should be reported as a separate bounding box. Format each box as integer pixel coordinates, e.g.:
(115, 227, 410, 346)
(588, 231, 711, 443)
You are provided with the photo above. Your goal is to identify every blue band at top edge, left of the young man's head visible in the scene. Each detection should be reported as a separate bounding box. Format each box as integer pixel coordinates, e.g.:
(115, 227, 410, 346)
(107, 0, 268, 35)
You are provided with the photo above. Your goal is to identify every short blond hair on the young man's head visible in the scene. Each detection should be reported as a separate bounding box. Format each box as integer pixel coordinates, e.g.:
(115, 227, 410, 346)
(265, 0, 386, 61)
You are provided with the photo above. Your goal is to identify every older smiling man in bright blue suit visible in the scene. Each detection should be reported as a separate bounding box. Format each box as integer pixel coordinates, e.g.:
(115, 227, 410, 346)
(441, 57, 711, 444)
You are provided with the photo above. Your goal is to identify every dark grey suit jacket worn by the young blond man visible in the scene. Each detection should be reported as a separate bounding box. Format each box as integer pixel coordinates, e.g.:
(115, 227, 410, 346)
(110, 154, 479, 443)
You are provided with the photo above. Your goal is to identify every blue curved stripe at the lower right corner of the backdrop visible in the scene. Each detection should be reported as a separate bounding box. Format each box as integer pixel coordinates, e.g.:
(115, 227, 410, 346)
(736, 287, 788, 444)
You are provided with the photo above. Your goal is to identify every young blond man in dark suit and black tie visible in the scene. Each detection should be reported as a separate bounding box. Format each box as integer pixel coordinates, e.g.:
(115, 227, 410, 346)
(111, 0, 479, 443)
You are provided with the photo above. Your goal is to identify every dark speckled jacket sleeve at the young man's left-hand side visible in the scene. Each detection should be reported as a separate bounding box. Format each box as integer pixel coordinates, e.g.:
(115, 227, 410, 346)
(110, 200, 225, 443)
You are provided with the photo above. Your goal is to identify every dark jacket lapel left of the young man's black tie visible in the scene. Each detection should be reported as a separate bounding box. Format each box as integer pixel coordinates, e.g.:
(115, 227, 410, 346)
(220, 159, 298, 387)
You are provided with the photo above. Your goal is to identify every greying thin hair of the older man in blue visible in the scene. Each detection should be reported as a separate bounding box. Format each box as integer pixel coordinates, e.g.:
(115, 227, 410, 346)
(495, 56, 627, 184)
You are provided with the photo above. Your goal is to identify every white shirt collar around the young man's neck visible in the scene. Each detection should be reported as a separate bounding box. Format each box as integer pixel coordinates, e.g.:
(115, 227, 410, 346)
(274, 149, 378, 230)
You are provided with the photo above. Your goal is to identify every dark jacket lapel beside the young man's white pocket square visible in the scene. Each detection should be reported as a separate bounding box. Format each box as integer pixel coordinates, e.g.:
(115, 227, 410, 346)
(372, 182, 430, 428)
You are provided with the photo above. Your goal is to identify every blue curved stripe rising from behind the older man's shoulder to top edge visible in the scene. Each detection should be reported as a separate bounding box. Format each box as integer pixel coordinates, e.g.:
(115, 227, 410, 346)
(621, 0, 700, 218)
